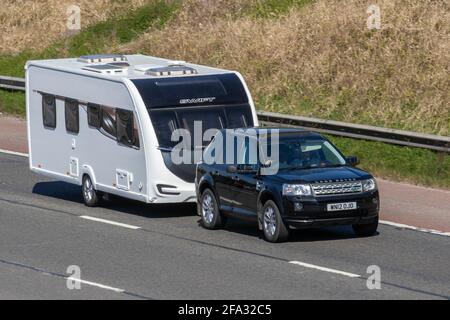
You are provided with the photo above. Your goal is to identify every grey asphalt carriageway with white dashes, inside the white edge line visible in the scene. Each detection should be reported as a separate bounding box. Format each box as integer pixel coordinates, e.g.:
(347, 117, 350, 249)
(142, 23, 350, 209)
(0, 154, 450, 299)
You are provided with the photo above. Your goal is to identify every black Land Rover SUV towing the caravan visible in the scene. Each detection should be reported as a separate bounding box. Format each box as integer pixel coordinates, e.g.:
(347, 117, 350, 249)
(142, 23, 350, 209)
(195, 128, 379, 242)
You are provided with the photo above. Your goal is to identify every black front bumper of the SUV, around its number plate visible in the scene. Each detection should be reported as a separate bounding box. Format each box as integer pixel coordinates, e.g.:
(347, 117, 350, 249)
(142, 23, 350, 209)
(282, 191, 380, 228)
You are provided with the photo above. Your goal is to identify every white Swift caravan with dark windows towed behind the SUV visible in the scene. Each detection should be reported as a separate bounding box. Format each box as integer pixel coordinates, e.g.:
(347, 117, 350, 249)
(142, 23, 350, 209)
(25, 55, 258, 206)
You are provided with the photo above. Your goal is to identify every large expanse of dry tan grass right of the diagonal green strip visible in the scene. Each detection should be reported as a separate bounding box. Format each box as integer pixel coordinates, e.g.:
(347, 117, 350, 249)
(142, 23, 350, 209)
(121, 0, 450, 135)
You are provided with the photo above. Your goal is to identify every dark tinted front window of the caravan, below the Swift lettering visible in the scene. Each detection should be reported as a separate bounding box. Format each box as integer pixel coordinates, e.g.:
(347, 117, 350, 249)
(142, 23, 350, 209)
(148, 104, 254, 148)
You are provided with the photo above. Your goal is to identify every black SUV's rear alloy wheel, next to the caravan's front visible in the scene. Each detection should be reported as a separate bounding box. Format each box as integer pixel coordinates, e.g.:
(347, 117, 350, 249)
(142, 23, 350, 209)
(200, 188, 227, 230)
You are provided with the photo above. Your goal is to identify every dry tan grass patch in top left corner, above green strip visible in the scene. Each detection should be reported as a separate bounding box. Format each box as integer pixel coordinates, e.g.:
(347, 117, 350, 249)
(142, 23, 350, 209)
(0, 0, 145, 54)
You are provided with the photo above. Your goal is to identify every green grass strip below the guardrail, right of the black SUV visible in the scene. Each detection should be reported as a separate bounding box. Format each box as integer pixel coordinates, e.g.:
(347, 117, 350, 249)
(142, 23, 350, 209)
(328, 136, 450, 189)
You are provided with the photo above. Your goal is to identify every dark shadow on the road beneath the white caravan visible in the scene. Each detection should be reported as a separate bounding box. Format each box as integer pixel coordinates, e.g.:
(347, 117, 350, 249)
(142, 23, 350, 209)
(32, 181, 196, 218)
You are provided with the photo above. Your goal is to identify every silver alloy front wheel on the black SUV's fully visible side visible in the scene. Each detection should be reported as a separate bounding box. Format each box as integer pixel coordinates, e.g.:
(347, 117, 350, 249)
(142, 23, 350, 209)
(262, 200, 289, 242)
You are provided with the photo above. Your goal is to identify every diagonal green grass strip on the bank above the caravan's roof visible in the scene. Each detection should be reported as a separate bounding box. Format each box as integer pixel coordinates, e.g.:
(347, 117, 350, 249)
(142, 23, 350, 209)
(0, 0, 181, 77)
